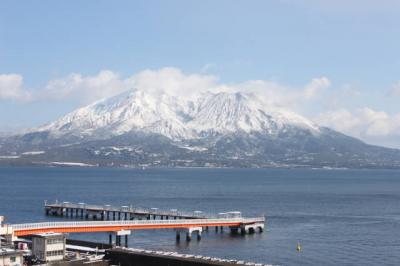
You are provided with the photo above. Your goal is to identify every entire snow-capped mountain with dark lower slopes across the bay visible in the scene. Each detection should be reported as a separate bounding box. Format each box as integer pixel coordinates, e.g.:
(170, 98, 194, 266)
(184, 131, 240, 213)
(0, 90, 400, 168)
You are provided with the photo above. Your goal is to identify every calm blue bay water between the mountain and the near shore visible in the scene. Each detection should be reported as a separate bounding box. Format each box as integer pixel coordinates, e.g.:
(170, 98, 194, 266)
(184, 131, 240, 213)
(0, 168, 400, 265)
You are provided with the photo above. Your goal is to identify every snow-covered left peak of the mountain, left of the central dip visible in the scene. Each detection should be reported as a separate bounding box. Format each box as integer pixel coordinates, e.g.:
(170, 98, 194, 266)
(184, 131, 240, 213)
(39, 91, 194, 138)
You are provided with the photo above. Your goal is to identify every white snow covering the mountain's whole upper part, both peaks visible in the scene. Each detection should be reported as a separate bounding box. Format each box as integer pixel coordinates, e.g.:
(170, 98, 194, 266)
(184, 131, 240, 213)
(35, 90, 319, 140)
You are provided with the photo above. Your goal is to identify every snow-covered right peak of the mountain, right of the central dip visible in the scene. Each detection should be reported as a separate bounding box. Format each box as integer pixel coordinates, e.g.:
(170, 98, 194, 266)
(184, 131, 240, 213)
(188, 93, 319, 134)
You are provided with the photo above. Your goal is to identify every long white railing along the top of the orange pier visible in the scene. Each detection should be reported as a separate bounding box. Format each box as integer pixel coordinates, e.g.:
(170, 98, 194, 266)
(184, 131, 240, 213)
(11, 217, 265, 231)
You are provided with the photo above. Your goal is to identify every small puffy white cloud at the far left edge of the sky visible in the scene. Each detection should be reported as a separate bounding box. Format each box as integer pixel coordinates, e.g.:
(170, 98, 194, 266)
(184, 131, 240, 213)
(0, 74, 29, 100)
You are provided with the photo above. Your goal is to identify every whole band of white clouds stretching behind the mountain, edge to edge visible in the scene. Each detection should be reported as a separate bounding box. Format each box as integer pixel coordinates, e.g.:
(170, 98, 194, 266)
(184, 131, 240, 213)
(0, 67, 400, 146)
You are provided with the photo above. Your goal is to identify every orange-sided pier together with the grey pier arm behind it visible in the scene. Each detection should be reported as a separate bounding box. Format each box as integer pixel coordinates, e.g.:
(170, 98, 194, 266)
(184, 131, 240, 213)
(0, 202, 265, 247)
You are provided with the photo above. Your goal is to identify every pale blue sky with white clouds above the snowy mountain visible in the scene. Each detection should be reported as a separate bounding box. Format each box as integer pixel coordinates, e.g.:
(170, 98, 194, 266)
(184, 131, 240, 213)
(0, 0, 400, 148)
